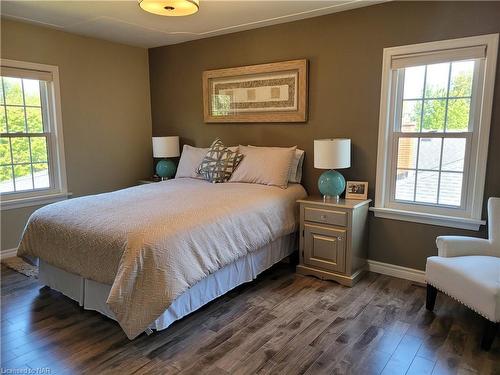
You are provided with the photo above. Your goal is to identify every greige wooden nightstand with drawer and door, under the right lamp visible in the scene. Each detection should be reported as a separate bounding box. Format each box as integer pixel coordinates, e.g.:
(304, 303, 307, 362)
(297, 197, 371, 286)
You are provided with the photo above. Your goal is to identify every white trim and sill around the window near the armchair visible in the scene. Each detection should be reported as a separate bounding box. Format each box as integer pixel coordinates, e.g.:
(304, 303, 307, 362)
(371, 34, 499, 230)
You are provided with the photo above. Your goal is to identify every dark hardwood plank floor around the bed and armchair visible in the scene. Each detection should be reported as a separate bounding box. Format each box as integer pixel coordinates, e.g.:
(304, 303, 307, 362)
(1, 264, 500, 375)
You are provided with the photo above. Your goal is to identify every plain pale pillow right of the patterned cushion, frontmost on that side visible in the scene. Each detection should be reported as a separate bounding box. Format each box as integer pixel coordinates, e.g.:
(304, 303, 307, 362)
(229, 145, 297, 189)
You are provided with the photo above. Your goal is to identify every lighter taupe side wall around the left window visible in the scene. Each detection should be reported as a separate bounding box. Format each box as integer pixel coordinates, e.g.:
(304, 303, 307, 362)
(1, 19, 152, 250)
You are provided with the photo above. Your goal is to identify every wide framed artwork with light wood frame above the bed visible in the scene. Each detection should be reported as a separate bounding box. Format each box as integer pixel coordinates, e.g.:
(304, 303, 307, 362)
(203, 59, 307, 123)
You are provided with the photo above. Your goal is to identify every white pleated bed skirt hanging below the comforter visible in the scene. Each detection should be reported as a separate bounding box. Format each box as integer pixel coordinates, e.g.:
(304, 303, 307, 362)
(38, 233, 298, 330)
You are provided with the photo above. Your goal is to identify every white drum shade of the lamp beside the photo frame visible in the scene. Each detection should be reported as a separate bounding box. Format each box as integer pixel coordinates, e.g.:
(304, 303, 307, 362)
(314, 138, 351, 169)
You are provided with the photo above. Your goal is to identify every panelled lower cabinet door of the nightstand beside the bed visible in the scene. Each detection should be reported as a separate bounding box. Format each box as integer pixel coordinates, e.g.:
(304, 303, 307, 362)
(304, 224, 346, 272)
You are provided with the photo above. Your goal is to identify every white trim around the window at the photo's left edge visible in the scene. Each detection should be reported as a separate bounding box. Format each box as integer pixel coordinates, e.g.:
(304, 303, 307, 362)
(0, 59, 71, 211)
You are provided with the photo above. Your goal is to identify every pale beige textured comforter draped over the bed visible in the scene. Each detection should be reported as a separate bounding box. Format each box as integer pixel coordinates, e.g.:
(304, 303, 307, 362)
(18, 178, 306, 339)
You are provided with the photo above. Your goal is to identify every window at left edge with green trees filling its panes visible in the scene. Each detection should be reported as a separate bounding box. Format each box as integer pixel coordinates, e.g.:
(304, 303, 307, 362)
(0, 60, 66, 209)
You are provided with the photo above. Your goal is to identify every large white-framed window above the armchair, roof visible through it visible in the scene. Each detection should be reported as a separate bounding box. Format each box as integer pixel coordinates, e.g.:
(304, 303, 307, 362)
(373, 34, 498, 229)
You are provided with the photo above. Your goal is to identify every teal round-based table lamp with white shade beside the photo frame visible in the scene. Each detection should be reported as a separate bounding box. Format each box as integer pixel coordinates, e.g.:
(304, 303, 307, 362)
(314, 138, 351, 201)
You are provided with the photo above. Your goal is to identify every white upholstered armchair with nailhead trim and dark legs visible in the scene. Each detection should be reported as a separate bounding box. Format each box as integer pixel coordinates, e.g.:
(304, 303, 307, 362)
(425, 198, 500, 350)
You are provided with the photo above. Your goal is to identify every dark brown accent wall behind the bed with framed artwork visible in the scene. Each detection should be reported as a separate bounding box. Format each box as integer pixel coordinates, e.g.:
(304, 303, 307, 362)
(149, 2, 500, 269)
